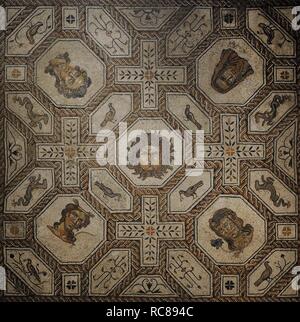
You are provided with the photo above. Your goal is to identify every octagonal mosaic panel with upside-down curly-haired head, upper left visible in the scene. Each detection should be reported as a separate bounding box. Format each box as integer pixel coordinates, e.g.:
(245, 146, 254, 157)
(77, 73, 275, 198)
(35, 39, 106, 107)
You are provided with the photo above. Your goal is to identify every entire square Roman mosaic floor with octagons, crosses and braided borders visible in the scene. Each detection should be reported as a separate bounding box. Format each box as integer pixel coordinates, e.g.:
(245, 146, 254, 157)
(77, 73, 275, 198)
(0, 0, 300, 302)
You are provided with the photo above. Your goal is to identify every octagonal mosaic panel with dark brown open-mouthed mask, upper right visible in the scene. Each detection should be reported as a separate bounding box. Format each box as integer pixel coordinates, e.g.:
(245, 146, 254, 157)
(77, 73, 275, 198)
(196, 38, 265, 105)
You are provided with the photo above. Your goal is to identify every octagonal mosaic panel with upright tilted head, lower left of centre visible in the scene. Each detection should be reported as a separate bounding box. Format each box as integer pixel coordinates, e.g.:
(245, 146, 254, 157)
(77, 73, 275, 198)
(35, 194, 106, 264)
